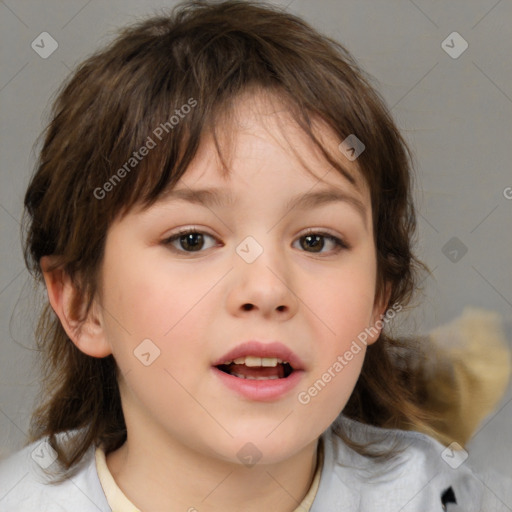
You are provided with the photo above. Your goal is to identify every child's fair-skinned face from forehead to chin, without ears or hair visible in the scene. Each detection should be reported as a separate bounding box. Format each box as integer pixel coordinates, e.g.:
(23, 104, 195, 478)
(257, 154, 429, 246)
(99, 91, 383, 463)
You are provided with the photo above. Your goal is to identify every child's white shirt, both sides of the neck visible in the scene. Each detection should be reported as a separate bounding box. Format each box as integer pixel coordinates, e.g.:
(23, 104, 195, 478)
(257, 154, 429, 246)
(0, 417, 512, 512)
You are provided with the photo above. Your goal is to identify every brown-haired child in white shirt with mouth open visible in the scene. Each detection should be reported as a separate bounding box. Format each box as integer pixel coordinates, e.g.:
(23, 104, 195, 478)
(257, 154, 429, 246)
(0, 1, 512, 512)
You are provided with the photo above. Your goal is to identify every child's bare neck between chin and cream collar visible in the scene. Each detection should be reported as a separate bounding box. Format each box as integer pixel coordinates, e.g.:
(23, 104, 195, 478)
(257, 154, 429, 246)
(107, 435, 318, 512)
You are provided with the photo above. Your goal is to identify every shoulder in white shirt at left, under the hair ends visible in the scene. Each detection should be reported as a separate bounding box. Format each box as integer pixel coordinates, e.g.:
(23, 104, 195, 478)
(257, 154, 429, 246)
(0, 439, 110, 512)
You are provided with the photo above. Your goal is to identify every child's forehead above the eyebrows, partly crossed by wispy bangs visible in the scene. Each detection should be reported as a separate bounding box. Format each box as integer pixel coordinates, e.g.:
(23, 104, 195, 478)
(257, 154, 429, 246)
(172, 91, 368, 196)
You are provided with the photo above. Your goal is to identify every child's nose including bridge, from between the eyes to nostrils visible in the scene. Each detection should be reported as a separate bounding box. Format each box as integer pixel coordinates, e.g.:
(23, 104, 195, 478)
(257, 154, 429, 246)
(230, 233, 297, 315)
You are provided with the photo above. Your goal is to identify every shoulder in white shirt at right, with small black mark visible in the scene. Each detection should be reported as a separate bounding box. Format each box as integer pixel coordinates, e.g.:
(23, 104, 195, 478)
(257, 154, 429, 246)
(312, 417, 511, 512)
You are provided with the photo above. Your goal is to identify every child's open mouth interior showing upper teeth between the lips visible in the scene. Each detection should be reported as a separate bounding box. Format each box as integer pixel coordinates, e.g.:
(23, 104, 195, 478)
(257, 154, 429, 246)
(216, 356, 294, 380)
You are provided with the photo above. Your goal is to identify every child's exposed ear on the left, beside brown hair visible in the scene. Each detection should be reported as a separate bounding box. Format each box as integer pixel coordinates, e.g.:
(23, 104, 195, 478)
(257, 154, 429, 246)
(40, 256, 112, 357)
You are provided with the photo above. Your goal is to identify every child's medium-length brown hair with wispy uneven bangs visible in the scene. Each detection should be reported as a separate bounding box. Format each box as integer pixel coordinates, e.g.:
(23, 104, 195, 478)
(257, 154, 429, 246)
(25, 1, 440, 476)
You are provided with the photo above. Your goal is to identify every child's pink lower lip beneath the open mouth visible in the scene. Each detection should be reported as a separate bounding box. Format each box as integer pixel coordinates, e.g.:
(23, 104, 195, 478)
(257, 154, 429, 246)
(212, 367, 304, 402)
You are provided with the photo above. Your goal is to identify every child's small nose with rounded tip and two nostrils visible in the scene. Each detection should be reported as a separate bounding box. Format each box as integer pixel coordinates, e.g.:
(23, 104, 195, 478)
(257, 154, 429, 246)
(227, 241, 298, 321)
